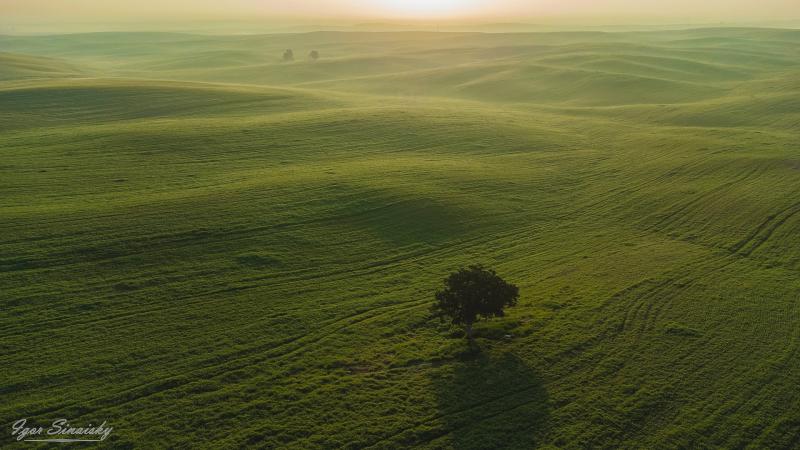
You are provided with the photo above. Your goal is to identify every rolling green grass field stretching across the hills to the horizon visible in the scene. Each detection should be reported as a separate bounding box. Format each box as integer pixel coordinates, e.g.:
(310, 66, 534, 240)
(0, 28, 800, 449)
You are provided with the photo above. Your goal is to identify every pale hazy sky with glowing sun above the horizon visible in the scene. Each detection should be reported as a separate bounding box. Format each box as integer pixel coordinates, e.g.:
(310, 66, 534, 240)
(0, 0, 800, 23)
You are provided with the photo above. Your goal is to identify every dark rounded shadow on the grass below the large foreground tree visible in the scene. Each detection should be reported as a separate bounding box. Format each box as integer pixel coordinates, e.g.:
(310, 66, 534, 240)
(431, 348, 550, 450)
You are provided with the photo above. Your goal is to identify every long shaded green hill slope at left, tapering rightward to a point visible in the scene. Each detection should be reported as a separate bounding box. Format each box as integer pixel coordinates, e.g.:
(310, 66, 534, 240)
(0, 79, 343, 129)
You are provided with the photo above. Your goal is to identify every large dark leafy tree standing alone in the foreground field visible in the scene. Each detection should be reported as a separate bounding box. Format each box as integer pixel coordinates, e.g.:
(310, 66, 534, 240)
(431, 266, 519, 342)
